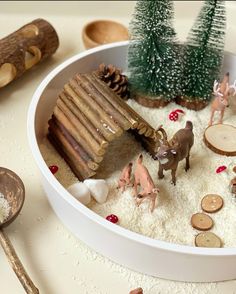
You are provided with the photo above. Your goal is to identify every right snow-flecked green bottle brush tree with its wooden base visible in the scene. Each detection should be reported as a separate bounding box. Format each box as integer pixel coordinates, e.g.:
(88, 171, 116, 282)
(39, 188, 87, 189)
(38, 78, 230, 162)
(176, 0, 226, 110)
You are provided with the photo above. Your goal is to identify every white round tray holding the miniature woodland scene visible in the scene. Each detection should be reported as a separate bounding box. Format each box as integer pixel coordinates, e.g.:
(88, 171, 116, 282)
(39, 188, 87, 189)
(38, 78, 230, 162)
(28, 41, 236, 282)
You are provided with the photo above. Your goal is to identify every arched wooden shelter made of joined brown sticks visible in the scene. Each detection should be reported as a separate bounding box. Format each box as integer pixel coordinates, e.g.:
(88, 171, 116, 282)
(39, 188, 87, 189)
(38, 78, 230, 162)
(48, 73, 160, 180)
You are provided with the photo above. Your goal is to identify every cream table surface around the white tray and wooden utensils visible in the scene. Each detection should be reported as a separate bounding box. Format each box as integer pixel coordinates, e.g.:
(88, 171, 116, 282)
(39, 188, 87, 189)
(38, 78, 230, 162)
(0, 1, 236, 294)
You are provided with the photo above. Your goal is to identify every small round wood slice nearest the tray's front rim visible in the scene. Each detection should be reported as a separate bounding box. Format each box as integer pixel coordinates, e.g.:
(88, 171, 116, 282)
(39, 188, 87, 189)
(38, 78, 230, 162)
(195, 232, 222, 248)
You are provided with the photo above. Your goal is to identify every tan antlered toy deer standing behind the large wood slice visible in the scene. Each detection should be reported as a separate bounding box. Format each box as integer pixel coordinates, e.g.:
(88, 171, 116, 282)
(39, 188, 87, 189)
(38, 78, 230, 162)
(209, 73, 236, 126)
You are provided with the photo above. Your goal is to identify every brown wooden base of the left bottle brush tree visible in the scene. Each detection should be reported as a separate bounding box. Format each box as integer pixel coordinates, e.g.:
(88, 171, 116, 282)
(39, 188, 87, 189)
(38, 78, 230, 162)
(132, 93, 170, 108)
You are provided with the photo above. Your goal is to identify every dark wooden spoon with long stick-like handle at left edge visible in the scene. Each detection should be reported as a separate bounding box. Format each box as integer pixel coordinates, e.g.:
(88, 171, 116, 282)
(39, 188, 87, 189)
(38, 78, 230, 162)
(0, 167, 39, 294)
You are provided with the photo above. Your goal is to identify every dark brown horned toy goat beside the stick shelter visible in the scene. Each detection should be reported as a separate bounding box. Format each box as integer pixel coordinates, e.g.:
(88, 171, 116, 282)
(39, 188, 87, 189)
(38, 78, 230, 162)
(154, 121, 194, 185)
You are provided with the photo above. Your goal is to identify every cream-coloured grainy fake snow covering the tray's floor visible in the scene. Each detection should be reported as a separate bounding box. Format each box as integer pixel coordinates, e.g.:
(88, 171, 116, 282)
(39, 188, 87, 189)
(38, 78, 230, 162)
(40, 100, 236, 247)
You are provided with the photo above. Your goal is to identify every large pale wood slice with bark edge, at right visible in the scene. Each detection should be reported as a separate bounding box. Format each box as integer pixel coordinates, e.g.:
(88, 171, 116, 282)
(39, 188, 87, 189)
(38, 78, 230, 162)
(204, 124, 236, 156)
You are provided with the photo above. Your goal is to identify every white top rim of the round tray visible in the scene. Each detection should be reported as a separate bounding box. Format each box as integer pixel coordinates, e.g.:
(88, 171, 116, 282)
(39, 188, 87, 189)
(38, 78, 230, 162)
(27, 41, 236, 257)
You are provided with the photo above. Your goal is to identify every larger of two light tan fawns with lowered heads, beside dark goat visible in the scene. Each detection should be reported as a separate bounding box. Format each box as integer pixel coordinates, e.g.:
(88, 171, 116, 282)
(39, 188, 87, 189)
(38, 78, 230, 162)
(134, 154, 160, 212)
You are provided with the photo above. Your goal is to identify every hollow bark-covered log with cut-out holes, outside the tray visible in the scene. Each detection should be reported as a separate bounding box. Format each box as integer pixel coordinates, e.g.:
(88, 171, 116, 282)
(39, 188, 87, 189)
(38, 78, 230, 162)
(0, 19, 59, 88)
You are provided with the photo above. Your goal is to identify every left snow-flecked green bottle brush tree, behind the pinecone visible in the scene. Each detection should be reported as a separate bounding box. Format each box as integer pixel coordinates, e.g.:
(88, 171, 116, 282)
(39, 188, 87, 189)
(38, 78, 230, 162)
(128, 0, 180, 107)
